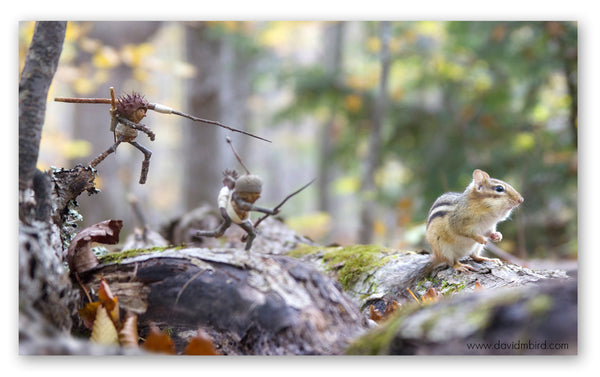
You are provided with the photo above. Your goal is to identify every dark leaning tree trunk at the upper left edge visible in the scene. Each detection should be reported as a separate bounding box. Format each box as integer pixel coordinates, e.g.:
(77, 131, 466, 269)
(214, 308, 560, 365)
(19, 21, 67, 191)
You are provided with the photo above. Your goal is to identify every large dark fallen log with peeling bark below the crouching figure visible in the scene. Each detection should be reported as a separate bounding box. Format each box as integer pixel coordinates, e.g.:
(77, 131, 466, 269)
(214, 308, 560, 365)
(80, 247, 366, 355)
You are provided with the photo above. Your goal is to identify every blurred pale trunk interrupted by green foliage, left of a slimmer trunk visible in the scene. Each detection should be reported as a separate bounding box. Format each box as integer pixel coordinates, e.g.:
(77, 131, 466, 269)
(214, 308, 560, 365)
(316, 22, 345, 219)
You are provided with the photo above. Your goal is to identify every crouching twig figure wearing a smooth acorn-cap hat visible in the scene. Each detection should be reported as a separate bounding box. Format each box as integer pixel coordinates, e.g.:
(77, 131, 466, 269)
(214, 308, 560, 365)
(194, 170, 279, 250)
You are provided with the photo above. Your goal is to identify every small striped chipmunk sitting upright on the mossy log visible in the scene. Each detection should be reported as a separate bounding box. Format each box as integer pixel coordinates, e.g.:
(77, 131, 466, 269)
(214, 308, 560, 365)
(425, 169, 524, 272)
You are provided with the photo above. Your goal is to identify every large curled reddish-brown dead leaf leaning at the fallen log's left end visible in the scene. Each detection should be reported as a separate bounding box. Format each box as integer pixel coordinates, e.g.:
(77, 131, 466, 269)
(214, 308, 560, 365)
(67, 220, 123, 273)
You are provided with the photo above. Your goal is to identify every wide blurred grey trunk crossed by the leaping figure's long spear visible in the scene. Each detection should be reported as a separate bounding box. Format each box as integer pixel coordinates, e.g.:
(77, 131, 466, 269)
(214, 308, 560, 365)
(181, 23, 225, 209)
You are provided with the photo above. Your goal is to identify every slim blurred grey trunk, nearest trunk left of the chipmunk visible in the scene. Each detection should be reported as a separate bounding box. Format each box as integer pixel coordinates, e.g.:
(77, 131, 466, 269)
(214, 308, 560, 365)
(358, 21, 391, 244)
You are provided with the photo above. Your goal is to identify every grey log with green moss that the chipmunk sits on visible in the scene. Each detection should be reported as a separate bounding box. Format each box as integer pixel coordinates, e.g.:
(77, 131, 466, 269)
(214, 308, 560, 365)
(289, 245, 568, 316)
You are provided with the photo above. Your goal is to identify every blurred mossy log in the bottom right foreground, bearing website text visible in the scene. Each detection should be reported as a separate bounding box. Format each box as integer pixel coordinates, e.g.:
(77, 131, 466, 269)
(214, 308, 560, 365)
(346, 279, 577, 355)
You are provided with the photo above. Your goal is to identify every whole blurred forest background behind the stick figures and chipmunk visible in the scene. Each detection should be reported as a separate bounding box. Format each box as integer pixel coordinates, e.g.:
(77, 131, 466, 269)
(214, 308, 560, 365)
(19, 21, 577, 259)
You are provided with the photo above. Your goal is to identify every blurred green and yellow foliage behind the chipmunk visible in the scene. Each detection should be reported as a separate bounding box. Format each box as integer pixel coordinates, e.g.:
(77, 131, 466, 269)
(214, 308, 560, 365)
(278, 22, 577, 257)
